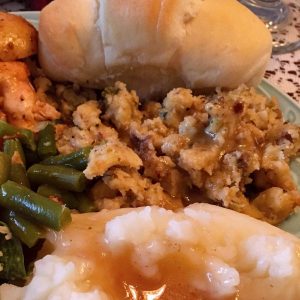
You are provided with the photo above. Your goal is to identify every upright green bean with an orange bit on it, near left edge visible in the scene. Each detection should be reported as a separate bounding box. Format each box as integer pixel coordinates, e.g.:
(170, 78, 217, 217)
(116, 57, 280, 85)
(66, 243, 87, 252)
(3, 139, 30, 187)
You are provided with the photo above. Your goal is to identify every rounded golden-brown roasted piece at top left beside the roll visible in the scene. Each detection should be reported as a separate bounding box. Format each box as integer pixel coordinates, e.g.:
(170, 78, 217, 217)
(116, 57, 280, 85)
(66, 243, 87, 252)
(0, 12, 38, 61)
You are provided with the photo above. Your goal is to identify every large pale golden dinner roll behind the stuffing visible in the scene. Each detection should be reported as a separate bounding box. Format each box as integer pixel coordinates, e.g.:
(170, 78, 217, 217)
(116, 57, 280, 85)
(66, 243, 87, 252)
(39, 0, 272, 98)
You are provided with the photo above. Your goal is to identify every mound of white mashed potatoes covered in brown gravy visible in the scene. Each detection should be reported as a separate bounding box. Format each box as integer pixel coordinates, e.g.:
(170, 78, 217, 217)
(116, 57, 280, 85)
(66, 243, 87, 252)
(0, 204, 300, 300)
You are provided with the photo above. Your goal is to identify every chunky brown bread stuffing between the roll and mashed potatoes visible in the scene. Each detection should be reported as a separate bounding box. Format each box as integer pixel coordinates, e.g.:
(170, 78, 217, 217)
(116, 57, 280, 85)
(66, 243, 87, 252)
(52, 82, 300, 224)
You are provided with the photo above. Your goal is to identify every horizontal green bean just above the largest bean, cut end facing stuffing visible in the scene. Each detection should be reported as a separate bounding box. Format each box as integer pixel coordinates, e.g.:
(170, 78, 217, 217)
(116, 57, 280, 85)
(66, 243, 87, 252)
(27, 164, 87, 192)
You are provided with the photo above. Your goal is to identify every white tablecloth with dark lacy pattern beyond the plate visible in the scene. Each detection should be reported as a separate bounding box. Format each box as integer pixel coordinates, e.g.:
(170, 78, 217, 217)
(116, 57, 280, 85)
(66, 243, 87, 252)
(0, 0, 300, 104)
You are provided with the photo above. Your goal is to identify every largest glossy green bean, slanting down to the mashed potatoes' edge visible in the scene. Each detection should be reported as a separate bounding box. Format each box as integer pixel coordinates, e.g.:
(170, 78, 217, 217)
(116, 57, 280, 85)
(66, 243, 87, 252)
(0, 180, 71, 231)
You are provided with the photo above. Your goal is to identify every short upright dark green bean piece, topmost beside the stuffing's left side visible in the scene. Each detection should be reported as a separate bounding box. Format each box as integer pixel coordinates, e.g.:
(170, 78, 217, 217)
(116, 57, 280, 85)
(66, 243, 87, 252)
(37, 124, 57, 159)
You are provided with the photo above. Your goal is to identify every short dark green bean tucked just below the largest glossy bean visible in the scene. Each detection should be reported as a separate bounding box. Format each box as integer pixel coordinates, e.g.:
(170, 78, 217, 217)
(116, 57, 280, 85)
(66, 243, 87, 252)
(2, 210, 43, 248)
